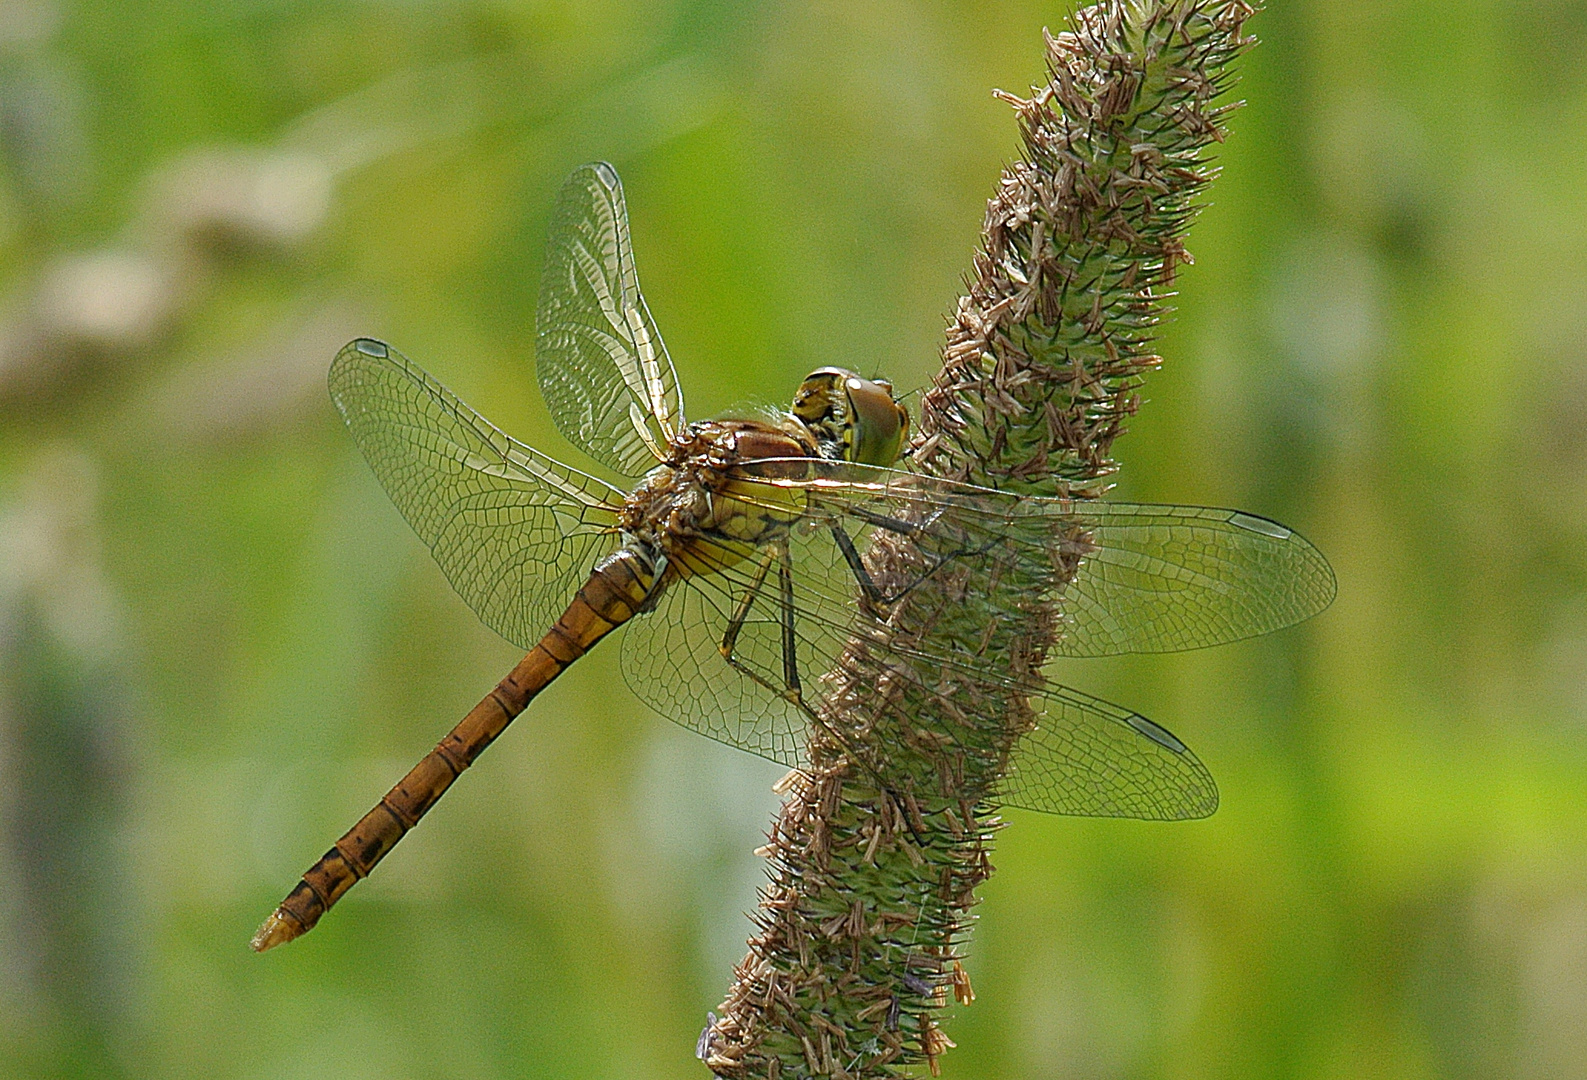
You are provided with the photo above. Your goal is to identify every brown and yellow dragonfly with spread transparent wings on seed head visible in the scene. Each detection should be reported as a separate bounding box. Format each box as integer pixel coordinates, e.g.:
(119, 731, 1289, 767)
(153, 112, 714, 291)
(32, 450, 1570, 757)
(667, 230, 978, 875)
(252, 162, 1335, 952)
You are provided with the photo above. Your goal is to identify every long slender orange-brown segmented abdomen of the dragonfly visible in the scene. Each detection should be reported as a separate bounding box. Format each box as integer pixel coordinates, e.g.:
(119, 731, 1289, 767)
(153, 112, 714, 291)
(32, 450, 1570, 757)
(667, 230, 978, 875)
(252, 549, 655, 953)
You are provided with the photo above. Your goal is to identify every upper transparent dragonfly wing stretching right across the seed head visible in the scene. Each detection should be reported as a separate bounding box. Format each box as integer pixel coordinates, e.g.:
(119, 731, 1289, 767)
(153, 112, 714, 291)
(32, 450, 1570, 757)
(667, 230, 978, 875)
(726, 458, 1336, 657)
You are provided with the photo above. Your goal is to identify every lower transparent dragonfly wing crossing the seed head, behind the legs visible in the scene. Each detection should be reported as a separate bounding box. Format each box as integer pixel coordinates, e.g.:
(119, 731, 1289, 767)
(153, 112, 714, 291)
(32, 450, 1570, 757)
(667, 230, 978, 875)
(624, 504, 1217, 818)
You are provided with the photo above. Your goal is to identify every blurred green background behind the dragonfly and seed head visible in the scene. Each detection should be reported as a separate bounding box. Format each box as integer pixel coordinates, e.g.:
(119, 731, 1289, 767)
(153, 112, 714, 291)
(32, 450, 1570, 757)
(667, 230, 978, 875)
(0, 0, 1587, 1080)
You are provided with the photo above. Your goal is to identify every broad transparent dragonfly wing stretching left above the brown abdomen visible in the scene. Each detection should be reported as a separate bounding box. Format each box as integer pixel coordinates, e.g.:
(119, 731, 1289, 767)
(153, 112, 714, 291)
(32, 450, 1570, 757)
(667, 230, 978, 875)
(330, 338, 622, 649)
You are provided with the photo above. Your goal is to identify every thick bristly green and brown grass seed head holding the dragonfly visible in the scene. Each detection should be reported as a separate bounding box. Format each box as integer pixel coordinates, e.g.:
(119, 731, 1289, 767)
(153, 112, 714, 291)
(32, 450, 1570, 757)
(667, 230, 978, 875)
(701, 0, 1252, 1080)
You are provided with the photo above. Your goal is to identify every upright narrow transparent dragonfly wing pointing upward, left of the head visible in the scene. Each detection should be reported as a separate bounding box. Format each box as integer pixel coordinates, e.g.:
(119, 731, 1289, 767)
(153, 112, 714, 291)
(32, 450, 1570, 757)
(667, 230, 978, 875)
(535, 162, 684, 477)
